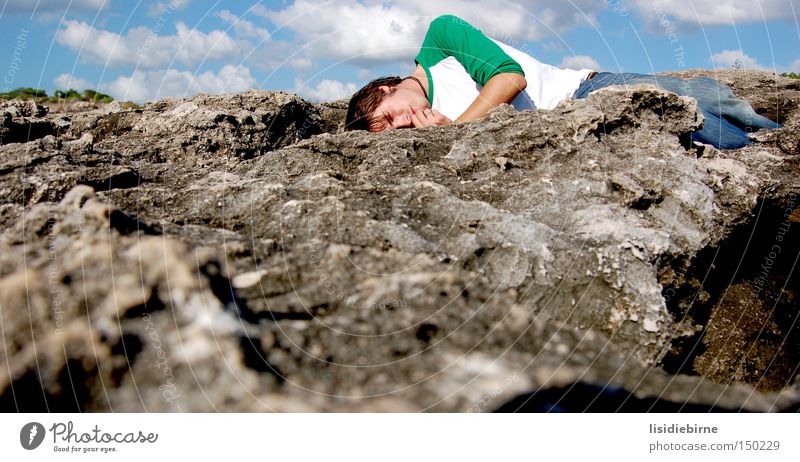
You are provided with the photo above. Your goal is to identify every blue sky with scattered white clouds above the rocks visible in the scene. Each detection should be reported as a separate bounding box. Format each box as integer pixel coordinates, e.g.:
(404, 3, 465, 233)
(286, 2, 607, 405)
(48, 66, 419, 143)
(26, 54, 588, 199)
(0, 0, 800, 102)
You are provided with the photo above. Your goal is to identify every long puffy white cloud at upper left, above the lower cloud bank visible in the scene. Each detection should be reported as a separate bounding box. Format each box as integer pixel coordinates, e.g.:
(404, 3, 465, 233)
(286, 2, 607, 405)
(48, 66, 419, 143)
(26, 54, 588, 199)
(56, 20, 242, 68)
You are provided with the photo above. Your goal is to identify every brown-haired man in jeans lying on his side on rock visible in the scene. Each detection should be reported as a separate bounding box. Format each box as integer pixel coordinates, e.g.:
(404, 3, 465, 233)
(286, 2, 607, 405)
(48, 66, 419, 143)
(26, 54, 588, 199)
(345, 15, 781, 149)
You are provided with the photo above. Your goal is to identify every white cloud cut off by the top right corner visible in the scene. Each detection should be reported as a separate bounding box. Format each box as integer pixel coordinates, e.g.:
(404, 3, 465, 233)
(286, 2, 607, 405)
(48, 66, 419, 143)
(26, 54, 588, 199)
(624, 0, 800, 26)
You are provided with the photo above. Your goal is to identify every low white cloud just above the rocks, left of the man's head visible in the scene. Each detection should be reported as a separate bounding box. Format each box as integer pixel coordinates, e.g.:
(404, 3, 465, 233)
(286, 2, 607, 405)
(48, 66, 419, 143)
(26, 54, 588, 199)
(101, 64, 258, 102)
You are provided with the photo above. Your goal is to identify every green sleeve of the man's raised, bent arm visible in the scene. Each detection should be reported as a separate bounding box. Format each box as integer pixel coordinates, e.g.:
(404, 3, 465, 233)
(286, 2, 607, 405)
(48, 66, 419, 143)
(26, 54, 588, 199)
(416, 15, 525, 85)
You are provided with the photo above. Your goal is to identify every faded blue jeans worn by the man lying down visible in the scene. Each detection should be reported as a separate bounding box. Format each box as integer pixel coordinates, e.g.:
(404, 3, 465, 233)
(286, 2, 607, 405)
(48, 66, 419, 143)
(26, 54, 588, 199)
(572, 72, 781, 149)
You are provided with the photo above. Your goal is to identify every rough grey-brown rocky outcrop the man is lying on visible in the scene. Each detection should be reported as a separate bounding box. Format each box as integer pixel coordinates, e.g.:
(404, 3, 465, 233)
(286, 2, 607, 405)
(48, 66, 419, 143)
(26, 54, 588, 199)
(0, 73, 800, 411)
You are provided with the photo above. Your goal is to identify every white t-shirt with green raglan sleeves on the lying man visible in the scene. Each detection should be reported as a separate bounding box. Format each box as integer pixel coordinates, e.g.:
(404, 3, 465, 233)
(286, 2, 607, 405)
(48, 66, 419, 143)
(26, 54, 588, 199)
(415, 15, 592, 120)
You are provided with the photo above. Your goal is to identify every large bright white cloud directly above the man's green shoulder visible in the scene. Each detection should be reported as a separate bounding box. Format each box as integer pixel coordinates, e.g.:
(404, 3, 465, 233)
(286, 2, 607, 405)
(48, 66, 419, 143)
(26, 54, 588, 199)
(251, 0, 606, 62)
